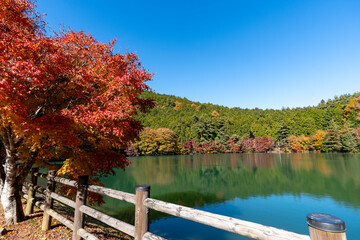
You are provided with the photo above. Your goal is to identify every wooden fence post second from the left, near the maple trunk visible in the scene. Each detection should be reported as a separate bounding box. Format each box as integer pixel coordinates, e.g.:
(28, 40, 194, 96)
(41, 170, 56, 231)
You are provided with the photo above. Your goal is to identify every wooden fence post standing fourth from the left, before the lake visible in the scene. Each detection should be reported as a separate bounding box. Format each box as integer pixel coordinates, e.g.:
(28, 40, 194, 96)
(135, 185, 150, 240)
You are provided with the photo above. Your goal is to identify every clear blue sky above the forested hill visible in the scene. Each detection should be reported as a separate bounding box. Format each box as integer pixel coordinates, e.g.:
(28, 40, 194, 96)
(37, 0, 360, 109)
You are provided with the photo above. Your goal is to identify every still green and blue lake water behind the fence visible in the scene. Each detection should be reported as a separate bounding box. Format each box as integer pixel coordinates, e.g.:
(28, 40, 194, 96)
(101, 153, 360, 240)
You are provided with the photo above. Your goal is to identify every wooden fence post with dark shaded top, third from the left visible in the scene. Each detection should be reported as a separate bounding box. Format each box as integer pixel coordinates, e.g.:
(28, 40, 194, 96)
(72, 176, 89, 240)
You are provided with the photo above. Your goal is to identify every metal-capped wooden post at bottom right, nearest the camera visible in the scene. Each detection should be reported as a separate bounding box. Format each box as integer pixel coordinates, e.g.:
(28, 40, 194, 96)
(306, 213, 346, 240)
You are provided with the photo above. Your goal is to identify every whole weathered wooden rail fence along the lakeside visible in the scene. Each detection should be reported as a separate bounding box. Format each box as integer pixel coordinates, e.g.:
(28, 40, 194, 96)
(21, 169, 346, 240)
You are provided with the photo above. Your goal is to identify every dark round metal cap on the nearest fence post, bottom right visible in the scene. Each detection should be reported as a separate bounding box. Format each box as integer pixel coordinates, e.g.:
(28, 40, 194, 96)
(306, 213, 346, 233)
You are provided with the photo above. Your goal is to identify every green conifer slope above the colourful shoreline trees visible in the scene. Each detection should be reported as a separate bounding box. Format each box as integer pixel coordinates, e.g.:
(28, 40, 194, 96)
(138, 92, 360, 143)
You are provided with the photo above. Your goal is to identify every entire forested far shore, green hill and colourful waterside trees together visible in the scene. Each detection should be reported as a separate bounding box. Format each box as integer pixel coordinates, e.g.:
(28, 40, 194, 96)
(126, 92, 360, 156)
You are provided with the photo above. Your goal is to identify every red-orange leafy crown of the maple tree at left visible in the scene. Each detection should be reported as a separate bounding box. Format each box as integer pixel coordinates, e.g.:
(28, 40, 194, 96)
(0, 0, 152, 224)
